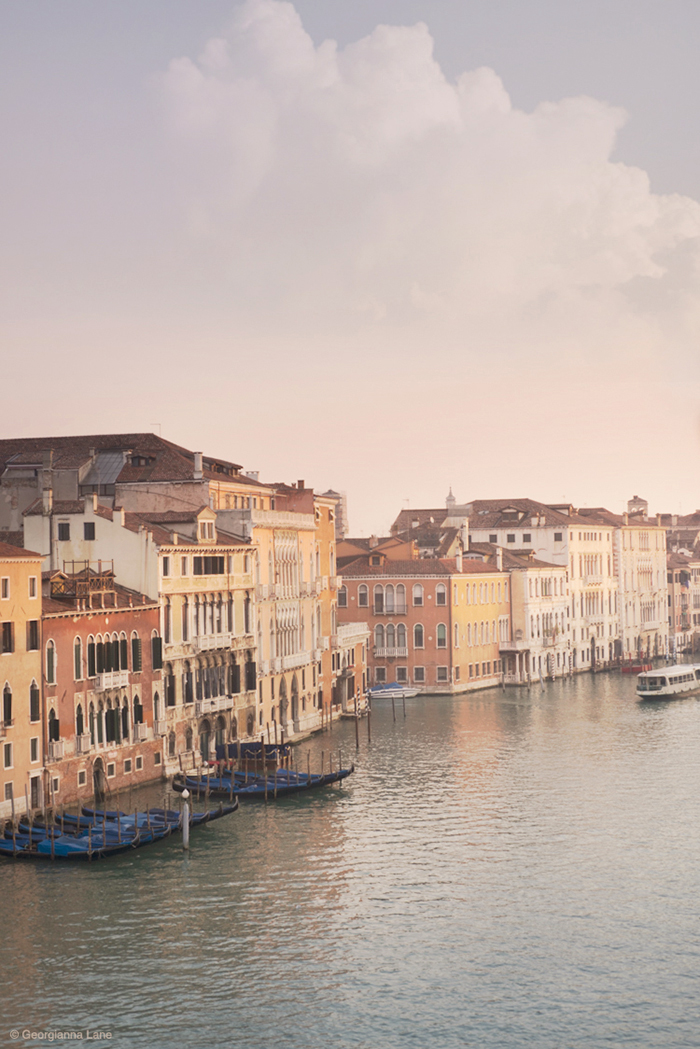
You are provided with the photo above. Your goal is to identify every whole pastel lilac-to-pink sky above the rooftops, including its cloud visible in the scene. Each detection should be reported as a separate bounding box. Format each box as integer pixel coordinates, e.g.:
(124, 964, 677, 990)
(0, 0, 700, 534)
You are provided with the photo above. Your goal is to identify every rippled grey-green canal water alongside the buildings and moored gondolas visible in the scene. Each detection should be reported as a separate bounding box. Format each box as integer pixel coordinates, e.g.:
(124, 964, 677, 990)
(0, 675, 700, 1049)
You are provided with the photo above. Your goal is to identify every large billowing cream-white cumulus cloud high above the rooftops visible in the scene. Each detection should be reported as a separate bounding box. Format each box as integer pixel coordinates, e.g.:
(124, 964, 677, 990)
(160, 0, 700, 362)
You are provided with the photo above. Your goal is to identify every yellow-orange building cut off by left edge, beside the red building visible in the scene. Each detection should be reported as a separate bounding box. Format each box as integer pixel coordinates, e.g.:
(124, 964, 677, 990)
(0, 542, 45, 818)
